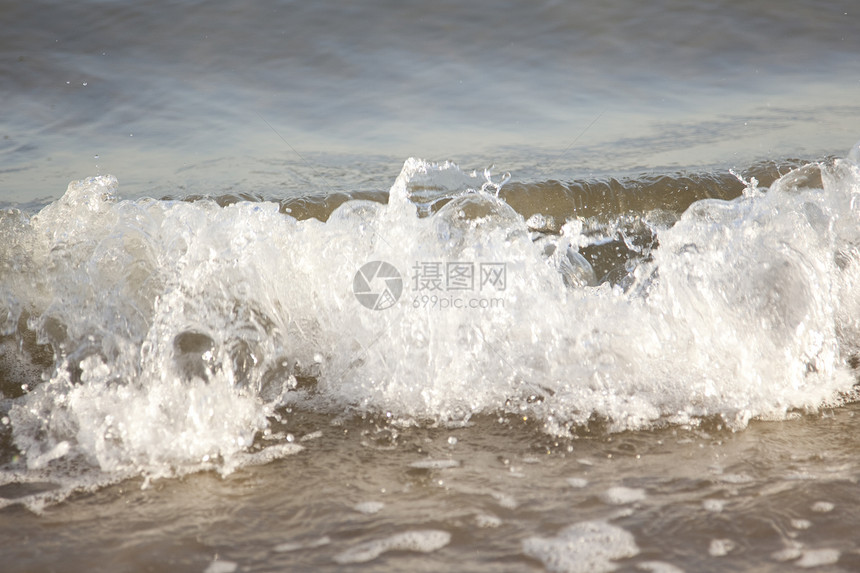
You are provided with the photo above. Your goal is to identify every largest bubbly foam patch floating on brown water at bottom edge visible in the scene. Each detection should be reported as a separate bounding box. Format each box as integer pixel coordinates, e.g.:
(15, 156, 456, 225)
(523, 521, 639, 573)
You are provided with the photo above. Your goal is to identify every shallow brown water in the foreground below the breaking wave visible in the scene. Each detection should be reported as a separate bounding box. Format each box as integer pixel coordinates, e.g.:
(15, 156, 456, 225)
(2, 406, 858, 571)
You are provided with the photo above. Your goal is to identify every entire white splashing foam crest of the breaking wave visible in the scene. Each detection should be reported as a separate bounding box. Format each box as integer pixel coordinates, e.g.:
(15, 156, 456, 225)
(0, 151, 860, 479)
